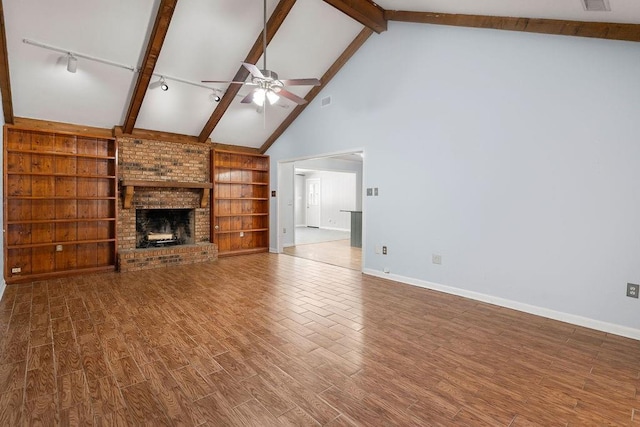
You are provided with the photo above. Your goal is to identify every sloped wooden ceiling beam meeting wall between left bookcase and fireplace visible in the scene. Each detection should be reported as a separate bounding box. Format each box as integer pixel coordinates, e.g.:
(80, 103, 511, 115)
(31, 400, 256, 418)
(122, 0, 178, 133)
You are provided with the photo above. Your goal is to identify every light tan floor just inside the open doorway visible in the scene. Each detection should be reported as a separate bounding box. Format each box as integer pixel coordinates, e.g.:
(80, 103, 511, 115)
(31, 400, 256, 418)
(283, 240, 362, 271)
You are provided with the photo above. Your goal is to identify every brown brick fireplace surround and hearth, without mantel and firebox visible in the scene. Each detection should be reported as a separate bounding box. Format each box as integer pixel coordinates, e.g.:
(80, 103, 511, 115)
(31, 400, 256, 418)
(118, 137, 217, 270)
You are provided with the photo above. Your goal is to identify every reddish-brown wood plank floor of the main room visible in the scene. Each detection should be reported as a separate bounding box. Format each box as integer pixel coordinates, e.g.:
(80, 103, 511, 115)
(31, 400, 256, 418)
(0, 254, 640, 427)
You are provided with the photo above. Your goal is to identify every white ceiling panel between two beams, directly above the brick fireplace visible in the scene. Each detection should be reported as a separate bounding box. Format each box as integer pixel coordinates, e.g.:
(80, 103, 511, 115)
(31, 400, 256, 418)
(136, 0, 277, 136)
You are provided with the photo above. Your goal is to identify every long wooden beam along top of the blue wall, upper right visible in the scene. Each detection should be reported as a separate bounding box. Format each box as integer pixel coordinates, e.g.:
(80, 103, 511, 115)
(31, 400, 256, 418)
(385, 10, 640, 42)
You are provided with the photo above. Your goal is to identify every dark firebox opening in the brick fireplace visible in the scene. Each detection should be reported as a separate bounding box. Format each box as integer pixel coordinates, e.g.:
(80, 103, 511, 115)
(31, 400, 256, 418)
(136, 209, 194, 248)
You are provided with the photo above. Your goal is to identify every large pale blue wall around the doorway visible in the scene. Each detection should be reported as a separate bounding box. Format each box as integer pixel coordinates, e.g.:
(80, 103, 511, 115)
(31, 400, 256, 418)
(268, 22, 640, 338)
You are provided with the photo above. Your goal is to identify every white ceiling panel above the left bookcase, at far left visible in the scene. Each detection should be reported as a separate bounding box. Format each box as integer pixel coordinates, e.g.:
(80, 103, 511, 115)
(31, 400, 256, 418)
(4, 0, 157, 127)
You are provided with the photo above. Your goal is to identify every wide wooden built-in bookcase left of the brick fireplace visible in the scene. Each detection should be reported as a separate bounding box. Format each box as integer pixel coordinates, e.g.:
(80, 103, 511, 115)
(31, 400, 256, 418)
(4, 126, 117, 283)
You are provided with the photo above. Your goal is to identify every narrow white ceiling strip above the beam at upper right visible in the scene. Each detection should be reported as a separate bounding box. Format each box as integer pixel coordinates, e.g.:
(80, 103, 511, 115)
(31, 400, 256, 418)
(376, 0, 640, 24)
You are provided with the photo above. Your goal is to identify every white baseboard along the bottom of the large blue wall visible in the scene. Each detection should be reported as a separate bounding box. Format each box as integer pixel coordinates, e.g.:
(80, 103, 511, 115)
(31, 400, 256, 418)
(362, 268, 640, 340)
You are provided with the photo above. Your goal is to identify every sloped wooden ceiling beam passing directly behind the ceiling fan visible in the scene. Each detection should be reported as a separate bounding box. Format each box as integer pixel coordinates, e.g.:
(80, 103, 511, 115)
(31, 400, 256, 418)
(198, 0, 296, 142)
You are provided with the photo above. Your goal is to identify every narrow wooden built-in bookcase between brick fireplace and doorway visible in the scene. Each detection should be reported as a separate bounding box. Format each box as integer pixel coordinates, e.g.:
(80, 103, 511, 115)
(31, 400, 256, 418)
(211, 150, 269, 256)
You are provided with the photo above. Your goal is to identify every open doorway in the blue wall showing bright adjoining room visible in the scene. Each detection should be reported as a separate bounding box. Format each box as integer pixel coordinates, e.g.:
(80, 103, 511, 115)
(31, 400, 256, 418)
(279, 152, 363, 271)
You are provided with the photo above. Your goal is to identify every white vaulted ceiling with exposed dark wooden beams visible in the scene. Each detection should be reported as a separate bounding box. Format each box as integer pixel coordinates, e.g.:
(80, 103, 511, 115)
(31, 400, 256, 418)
(0, 0, 640, 151)
